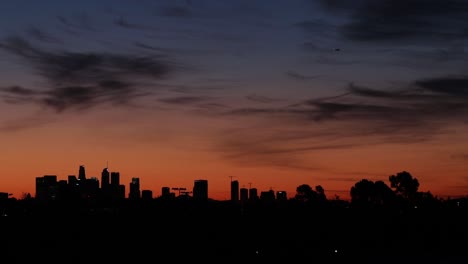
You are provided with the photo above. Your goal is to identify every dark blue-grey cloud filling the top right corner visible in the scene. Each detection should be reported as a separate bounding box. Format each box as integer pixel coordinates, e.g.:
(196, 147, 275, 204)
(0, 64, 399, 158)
(320, 0, 468, 44)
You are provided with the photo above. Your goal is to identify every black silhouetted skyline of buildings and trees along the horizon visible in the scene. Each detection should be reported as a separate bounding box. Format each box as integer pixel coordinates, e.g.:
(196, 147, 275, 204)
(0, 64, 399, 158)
(0, 163, 462, 203)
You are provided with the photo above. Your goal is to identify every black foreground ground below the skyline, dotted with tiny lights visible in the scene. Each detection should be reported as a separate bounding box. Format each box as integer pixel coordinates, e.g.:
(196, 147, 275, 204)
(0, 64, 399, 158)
(0, 201, 468, 264)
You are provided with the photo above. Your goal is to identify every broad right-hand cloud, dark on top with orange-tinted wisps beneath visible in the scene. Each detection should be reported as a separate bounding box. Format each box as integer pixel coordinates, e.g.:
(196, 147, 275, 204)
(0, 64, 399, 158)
(214, 76, 468, 169)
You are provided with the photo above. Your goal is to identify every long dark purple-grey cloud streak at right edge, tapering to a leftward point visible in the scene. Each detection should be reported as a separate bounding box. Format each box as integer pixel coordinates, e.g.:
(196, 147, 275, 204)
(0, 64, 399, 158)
(231, 76, 468, 127)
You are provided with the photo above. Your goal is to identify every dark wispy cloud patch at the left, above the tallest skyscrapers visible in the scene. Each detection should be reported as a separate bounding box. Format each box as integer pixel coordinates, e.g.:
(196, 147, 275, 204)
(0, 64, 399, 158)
(0, 37, 177, 112)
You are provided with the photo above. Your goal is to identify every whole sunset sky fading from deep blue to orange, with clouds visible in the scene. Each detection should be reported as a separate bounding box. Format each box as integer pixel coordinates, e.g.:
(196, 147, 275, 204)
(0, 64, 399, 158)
(0, 0, 468, 200)
